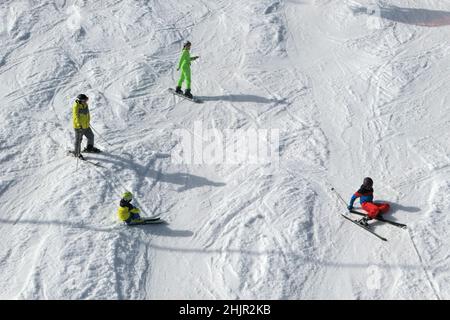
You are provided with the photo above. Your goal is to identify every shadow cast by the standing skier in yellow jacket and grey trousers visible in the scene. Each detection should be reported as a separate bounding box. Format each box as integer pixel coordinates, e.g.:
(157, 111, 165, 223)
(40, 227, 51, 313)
(91, 152, 225, 192)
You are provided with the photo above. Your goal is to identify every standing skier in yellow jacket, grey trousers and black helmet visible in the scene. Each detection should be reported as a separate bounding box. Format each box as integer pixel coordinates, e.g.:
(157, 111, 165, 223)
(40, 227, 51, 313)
(72, 94, 100, 160)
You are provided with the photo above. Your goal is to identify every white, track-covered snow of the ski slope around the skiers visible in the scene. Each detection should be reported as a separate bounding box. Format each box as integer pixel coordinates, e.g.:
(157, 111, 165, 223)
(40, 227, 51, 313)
(0, 0, 450, 299)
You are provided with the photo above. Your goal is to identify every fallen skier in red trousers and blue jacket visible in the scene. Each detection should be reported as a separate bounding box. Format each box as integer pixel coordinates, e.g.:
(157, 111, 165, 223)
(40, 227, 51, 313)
(348, 177, 390, 225)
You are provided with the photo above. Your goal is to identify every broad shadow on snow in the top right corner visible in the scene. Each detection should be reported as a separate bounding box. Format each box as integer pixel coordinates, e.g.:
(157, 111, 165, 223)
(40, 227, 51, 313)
(351, 6, 450, 27)
